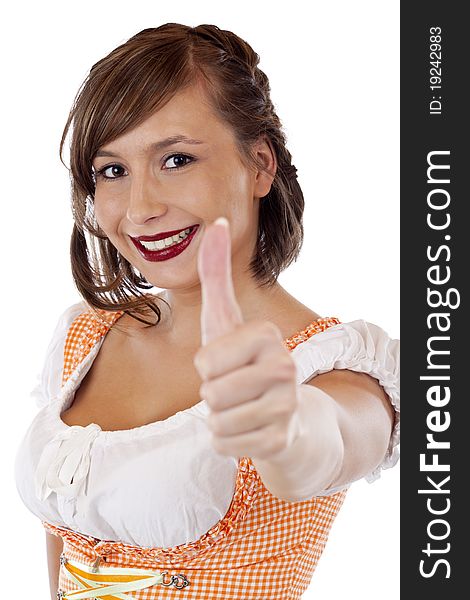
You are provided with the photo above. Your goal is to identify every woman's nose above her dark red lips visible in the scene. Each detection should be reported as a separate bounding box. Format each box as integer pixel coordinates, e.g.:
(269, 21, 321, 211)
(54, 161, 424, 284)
(127, 168, 168, 225)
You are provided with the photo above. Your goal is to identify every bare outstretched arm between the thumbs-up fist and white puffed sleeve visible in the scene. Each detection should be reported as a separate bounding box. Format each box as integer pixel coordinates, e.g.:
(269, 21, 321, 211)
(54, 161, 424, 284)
(253, 370, 394, 501)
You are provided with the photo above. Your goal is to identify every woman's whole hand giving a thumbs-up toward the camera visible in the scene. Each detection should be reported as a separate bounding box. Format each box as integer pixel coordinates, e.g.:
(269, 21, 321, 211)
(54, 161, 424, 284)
(194, 217, 300, 460)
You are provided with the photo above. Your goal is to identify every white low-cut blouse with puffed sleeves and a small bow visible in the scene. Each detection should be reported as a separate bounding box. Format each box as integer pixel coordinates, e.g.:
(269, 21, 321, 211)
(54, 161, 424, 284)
(15, 302, 400, 548)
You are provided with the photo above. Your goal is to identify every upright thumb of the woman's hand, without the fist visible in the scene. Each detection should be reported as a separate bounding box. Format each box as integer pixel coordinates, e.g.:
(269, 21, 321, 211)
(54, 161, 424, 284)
(197, 217, 243, 346)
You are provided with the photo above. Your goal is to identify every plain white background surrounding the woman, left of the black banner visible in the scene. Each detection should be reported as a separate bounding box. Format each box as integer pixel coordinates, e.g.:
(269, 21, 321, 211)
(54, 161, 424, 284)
(0, 0, 399, 600)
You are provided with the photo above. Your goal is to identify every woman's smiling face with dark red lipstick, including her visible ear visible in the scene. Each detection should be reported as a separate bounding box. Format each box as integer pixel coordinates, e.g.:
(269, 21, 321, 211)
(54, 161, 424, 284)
(93, 86, 272, 289)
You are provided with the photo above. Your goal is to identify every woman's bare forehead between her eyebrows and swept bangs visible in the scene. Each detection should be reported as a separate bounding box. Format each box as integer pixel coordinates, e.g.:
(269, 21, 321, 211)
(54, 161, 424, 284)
(101, 85, 239, 152)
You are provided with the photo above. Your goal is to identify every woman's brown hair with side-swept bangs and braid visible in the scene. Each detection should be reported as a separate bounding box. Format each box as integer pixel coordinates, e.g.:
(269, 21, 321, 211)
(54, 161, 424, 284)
(60, 23, 304, 325)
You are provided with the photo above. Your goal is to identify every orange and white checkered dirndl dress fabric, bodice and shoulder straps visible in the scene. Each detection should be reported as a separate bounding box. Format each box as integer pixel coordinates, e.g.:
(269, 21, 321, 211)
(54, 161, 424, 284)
(43, 310, 346, 600)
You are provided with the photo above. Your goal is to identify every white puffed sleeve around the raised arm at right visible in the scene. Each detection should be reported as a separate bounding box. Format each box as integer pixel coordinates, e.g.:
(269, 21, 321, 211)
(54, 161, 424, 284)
(292, 319, 400, 482)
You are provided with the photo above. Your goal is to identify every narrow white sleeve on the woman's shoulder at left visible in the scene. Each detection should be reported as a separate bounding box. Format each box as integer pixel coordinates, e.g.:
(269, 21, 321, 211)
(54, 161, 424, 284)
(31, 301, 87, 408)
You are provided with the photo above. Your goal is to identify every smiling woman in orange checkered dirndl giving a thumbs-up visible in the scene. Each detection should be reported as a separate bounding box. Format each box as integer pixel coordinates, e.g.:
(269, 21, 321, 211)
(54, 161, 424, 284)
(16, 23, 399, 599)
